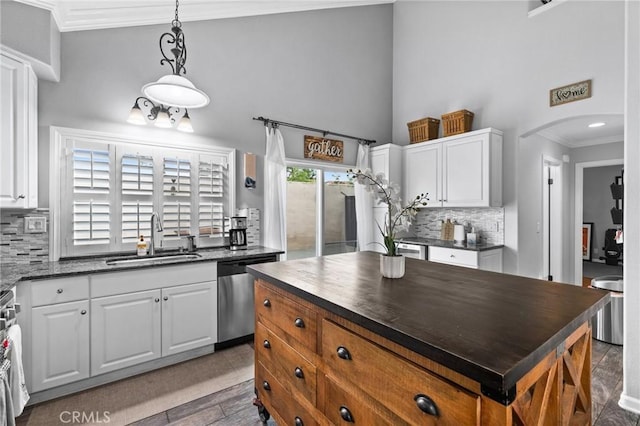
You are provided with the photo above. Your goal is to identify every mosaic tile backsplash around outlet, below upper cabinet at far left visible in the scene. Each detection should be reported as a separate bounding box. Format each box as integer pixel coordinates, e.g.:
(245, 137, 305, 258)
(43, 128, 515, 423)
(0, 209, 49, 266)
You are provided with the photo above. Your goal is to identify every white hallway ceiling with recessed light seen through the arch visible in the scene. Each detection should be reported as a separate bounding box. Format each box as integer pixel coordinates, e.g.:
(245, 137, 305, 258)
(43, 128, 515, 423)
(535, 114, 624, 148)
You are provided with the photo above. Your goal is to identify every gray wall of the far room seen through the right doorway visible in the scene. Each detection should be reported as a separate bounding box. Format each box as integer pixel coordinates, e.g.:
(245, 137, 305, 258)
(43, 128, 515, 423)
(582, 166, 622, 260)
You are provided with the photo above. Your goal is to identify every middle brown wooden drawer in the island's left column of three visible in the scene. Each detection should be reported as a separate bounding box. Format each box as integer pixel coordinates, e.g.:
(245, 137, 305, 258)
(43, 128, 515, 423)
(255, 322, 316, 405)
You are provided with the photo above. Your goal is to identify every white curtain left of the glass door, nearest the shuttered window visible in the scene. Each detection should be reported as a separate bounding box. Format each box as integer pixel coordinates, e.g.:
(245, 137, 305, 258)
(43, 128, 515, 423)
(264, 126, 287, 259)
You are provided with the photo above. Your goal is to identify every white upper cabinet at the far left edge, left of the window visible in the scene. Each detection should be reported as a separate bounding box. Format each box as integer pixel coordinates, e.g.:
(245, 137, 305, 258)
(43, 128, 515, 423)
(0, 51, 38, 209)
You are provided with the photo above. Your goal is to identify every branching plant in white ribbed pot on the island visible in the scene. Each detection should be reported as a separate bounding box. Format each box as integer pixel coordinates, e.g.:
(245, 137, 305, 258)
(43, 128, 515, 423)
(347, 169, 429, 278)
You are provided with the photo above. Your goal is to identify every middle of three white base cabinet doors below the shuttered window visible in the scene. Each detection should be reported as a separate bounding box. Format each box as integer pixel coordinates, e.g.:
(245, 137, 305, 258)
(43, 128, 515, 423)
(91, 290, 162, 375)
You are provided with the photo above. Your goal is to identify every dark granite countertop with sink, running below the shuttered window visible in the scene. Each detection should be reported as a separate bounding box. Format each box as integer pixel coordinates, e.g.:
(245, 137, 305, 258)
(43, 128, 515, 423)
(0, 246, 284, 291)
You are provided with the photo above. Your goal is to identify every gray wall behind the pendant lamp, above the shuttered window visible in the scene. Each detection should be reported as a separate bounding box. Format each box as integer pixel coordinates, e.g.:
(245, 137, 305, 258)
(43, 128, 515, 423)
(39, 5, 393, 209)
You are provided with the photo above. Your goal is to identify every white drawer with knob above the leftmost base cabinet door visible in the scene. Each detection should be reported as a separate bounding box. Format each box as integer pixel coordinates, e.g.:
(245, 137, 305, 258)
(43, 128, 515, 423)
(31, 275, 89, 307)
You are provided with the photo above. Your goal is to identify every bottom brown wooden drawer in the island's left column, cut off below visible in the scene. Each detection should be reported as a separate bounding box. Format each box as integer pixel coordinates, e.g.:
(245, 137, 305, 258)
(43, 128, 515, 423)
(255, 362, 318, 426)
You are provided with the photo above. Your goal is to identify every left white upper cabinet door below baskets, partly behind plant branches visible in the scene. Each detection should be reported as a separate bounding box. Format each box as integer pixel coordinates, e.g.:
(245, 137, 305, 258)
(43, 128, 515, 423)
(403, 143, 442, 207)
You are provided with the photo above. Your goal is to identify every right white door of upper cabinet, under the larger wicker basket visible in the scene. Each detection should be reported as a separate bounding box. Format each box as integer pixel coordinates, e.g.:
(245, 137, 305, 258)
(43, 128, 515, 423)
(442, 134, 489, 207)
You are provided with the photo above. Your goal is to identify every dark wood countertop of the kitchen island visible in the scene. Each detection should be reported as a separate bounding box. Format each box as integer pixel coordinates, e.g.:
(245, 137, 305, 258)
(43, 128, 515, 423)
(247, 252, 609, 404)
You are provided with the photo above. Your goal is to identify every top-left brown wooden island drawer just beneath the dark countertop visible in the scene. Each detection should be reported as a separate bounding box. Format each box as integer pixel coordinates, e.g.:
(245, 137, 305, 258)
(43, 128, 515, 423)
(255, 280, 318, 352)
